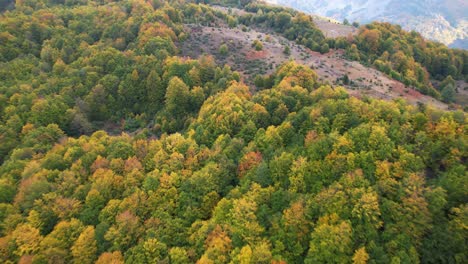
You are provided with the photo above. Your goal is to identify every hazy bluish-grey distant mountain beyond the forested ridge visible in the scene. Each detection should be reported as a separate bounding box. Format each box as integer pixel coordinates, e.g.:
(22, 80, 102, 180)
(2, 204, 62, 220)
(266, 0, 468, 49)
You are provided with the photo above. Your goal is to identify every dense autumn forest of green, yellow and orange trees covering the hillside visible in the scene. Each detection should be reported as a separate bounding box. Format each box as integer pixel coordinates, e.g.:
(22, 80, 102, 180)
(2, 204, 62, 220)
(0, 0, 468, 264)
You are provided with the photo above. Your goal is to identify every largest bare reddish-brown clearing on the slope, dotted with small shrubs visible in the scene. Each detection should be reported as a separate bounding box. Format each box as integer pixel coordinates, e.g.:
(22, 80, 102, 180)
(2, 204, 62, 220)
(179, 22, 448, 109)
